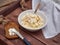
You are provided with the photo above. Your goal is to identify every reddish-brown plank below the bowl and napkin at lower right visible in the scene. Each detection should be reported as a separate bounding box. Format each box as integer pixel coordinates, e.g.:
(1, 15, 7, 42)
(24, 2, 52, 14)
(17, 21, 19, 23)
(25, 31, 60, 45)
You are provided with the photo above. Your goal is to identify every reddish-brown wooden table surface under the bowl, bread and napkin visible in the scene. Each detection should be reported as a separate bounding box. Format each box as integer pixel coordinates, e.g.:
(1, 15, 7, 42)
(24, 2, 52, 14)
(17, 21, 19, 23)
(0, 0, 60, 45)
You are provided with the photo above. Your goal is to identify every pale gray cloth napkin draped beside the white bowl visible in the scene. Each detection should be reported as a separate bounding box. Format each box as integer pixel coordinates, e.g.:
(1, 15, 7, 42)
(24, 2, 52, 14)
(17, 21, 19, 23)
(32, 0, 60, 38)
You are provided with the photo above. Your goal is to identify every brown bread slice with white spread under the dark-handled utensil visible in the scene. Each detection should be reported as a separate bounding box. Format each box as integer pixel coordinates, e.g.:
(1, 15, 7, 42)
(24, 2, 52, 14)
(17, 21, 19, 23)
(5, 22, 19, 39)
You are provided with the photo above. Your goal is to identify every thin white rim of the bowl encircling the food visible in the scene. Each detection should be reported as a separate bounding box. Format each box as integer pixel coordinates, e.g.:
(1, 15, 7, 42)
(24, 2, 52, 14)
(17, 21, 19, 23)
(18, 10, 48, 31)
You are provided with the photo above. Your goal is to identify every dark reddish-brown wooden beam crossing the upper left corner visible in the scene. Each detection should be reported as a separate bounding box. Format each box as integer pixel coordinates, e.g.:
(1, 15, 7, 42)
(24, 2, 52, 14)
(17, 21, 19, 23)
(0, 0, 20, 16)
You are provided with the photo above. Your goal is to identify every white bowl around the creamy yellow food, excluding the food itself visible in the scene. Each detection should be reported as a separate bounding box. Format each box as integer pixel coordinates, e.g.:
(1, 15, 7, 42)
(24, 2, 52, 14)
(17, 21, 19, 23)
(18, 10, 47, 31)
